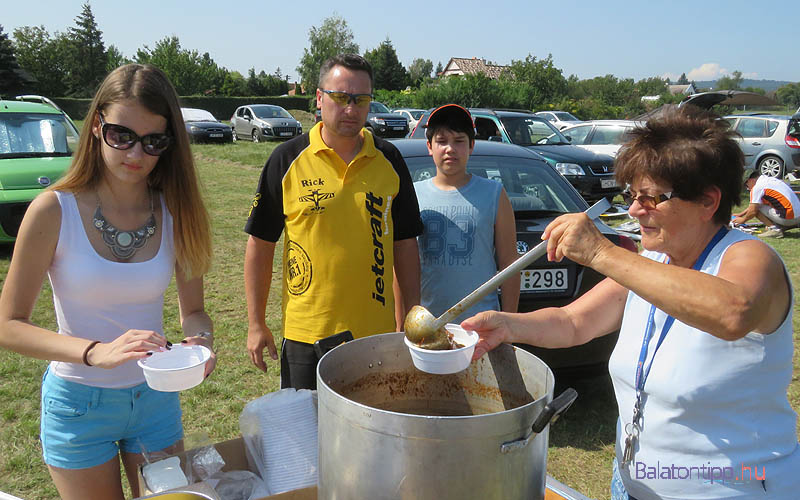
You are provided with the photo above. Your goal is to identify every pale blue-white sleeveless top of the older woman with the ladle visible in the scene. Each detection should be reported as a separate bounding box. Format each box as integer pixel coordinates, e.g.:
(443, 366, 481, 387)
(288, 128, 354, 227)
(609, 230, 800, 500)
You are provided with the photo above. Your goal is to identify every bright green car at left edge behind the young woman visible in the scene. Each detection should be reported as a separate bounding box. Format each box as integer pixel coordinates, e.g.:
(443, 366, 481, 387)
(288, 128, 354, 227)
(0, 96, 78, 243)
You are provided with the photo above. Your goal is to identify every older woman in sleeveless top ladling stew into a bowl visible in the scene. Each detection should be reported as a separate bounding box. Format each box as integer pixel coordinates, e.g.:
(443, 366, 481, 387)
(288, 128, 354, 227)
(462, 107, 800, 499)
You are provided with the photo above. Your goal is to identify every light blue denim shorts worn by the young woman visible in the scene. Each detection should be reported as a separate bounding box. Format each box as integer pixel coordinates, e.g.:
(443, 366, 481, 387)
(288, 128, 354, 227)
(40, 370, 183, 469)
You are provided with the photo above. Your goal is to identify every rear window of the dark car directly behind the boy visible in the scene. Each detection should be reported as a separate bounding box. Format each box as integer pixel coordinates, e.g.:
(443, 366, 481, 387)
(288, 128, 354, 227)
(405, 156, 584, 216)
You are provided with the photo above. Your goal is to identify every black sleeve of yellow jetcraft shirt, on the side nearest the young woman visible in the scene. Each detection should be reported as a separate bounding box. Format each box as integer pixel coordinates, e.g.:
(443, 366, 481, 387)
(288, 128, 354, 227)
(244, 134, 308, 243)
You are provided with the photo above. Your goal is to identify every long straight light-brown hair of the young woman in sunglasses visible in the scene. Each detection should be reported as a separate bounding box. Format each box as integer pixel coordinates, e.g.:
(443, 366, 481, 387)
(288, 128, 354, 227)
(51, 64, 212, 277)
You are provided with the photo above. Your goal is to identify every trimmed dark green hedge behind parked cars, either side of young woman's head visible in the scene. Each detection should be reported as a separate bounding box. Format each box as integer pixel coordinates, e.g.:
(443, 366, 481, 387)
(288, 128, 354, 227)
(53, 95, 314, 120)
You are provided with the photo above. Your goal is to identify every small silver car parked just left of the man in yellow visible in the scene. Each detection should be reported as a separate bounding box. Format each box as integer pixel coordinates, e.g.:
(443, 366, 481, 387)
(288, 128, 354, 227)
(231, 104, 303, 142)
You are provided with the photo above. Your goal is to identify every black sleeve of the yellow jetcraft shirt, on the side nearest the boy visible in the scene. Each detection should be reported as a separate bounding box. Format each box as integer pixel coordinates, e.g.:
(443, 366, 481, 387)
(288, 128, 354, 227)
(375, 137, 425, 241)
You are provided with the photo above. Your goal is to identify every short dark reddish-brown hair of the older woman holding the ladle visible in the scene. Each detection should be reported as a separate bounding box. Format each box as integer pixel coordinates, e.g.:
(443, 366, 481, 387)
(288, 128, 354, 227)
(615, 105, 744, 224)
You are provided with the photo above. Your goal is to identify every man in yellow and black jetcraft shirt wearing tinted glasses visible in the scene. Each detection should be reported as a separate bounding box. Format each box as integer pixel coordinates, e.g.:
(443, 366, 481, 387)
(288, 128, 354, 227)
(244, 54, 423, 389)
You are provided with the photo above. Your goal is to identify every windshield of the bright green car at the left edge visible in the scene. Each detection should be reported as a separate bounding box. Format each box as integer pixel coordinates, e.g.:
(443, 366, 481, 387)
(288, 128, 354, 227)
(0, 113, 78, 158)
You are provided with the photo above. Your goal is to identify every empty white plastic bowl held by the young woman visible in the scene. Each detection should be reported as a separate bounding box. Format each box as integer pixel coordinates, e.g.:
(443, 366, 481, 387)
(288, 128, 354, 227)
(138, 344, 211, 392)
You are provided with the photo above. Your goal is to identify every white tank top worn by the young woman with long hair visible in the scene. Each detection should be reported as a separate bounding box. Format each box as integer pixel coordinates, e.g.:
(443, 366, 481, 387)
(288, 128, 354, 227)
(47, 191, 175, 389)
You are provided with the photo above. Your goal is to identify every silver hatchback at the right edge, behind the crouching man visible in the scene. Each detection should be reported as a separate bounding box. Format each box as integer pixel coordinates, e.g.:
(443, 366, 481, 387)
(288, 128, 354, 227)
(724, 115, 800, 179)
